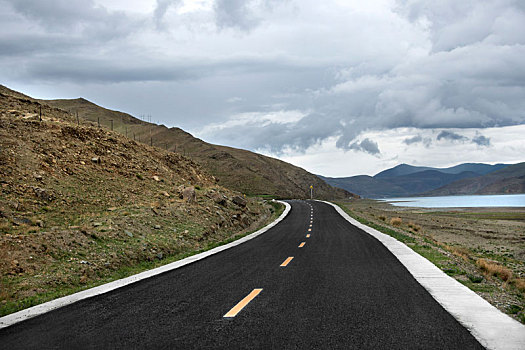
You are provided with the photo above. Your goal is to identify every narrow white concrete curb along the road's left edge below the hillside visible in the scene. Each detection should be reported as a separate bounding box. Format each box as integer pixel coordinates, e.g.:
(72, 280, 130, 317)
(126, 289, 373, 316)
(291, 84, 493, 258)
(0, 201, 291, 329)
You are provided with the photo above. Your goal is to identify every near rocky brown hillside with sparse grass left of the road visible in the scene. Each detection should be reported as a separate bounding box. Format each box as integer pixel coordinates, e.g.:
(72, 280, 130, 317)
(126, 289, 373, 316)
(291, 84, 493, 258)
(0, 88, 276, 315)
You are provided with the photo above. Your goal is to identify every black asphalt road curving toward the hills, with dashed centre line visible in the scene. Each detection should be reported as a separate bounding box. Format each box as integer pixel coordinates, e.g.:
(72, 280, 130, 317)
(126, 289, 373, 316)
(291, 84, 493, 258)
(0, 201, 482, 349)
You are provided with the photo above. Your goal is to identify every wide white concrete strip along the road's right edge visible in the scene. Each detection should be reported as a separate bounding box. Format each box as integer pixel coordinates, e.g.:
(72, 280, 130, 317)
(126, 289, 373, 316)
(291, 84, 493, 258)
(323, 201, 525, 350)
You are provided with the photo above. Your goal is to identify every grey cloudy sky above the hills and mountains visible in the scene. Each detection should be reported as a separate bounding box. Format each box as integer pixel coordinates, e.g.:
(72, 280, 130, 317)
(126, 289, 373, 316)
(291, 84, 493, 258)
(0, 0, 525, 176)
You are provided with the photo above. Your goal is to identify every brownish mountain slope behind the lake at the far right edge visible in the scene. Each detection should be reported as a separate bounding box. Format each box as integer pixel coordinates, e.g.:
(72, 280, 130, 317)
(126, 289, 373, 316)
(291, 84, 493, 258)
(425, 162, 525, 196)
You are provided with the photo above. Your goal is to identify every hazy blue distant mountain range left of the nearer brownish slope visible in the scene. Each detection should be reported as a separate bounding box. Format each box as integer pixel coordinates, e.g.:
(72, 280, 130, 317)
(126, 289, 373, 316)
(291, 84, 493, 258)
(322, 163, 515, 198)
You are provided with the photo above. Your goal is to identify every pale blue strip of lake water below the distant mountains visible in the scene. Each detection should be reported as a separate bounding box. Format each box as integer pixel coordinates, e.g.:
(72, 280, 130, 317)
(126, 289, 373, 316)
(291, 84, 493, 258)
(381, 194, 525, 208)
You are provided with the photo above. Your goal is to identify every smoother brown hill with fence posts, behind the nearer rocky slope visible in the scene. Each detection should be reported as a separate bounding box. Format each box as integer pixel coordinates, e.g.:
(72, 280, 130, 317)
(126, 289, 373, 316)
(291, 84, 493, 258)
(42, 99, 352, 199)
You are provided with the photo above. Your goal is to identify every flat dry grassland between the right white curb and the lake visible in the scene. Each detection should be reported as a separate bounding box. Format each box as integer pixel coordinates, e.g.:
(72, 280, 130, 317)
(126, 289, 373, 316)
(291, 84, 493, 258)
(336, 199, 525, 323)
